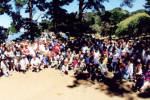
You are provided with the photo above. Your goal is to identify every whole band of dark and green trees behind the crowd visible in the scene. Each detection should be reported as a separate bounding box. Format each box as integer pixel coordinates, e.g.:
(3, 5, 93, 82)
(0, 0, 150, 39)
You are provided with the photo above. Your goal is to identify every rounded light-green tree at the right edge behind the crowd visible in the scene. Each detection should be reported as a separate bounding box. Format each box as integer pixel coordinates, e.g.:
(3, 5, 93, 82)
(116, 13, 150, 37)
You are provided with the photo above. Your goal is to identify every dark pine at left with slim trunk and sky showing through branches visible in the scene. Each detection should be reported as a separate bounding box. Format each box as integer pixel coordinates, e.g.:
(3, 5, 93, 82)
(11, 0, 45, 40)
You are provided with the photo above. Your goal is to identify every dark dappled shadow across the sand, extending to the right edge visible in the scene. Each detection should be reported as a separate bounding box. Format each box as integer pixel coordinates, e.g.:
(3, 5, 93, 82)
(67, 73, 150, 100)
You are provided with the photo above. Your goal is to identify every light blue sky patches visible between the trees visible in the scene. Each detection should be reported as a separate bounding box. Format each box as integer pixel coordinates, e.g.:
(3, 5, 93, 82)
(0, 0, 146, 28)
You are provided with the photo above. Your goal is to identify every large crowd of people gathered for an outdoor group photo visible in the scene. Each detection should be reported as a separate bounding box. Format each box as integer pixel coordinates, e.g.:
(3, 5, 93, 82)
(0, 33, 150, 91)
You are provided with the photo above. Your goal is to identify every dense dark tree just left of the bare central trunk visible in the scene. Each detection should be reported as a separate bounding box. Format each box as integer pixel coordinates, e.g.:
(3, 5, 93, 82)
(43, 0, 73, 33)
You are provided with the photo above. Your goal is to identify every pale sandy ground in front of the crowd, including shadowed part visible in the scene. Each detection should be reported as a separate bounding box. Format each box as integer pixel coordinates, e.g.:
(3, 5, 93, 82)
(0, 69, 150, 100)
